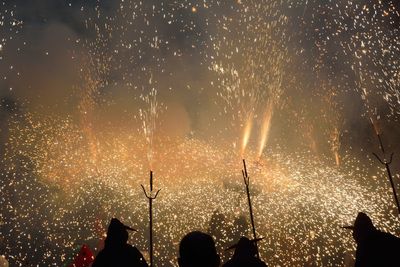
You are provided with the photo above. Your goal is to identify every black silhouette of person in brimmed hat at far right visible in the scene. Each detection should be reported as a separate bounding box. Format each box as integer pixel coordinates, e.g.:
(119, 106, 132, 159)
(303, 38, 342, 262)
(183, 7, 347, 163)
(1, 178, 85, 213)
(345, 212, 400, 267)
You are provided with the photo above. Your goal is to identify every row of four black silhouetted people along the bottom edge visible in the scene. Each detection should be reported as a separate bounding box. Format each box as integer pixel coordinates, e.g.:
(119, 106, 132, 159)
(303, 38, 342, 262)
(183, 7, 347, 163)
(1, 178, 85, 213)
(92, 212, 400, 267)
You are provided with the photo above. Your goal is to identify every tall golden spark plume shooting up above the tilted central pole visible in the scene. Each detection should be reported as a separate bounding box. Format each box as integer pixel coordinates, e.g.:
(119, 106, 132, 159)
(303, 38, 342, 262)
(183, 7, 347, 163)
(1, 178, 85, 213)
(211, 1, 288, 155)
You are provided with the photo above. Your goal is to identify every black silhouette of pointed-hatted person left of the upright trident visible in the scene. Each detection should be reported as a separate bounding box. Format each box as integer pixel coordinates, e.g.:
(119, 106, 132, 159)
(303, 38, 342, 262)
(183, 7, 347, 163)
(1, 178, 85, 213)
(92, 218, 148, 267)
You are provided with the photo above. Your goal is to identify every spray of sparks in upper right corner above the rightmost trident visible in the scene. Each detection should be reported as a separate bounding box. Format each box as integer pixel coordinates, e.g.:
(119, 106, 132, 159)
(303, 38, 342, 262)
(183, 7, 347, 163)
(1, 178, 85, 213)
(312, 1, 400, 118)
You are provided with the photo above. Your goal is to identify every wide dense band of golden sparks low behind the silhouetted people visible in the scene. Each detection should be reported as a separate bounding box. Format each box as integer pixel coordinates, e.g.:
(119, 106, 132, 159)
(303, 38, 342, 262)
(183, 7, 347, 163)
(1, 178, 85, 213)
(2, 115, 399, 266)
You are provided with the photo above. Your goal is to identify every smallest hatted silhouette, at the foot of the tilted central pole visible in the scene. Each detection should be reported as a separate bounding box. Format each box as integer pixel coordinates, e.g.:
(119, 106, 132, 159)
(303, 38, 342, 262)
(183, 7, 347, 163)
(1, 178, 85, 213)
(222, 237, 267, 267)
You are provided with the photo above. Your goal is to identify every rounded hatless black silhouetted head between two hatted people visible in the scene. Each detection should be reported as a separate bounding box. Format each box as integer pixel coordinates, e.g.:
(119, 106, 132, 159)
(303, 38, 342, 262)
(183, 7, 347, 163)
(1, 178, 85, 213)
(178, 231, 220, 267)
